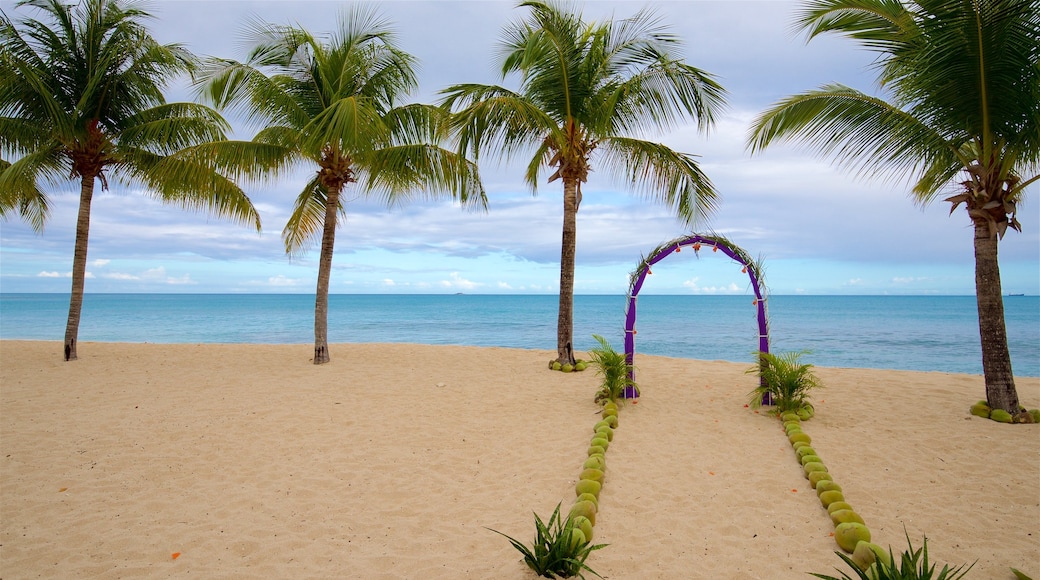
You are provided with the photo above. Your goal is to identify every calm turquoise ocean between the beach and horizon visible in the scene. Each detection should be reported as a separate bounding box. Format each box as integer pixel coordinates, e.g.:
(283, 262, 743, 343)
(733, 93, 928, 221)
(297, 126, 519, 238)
(0, 293, 1040, 376)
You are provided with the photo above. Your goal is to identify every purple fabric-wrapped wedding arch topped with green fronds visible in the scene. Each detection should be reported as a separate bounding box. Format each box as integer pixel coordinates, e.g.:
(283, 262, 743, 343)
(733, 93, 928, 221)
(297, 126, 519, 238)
(625, 234, 772, 404)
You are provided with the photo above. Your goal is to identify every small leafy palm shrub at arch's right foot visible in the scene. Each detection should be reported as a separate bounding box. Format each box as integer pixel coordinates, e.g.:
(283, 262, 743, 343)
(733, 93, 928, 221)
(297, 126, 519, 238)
(746, 350, 822, 420)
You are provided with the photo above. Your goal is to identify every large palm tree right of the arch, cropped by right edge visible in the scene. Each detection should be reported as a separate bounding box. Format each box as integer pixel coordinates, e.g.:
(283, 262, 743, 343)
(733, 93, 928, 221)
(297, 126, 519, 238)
(748, 0, 1040, 414)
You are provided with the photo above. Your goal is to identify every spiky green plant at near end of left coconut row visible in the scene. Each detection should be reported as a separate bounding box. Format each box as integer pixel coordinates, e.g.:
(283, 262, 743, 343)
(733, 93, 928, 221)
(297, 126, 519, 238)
(488, 503, 606, 580)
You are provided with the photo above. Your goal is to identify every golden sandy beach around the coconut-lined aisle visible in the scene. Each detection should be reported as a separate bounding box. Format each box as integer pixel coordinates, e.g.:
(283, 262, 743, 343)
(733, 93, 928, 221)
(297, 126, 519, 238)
(0, 341, 1040, 580)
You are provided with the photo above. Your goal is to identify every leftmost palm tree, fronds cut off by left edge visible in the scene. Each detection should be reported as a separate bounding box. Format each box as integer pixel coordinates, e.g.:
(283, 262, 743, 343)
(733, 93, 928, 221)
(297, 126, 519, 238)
(0, 0, 260, 361)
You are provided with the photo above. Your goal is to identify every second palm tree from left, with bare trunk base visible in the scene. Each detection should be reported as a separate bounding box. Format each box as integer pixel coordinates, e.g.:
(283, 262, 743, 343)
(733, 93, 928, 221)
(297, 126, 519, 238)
(200, 7, 487, 364)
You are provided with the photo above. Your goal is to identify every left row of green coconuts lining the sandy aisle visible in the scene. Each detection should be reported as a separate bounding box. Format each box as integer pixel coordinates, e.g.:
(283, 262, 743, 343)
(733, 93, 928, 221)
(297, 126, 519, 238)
(567, 401, 618, 546)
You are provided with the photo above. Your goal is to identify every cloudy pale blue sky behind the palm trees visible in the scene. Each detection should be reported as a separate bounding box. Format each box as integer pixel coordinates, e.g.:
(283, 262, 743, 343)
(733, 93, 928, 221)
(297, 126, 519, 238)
(0, 0, 1040, 295)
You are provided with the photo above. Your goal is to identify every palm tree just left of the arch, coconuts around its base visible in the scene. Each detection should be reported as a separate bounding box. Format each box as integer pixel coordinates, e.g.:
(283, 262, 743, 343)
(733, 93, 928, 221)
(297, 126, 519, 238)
(443, 1, 725, 364)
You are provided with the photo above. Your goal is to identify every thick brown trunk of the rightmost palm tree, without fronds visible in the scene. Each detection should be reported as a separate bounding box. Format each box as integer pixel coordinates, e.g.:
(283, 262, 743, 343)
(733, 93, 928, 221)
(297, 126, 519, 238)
(974, 221, 1019, 415)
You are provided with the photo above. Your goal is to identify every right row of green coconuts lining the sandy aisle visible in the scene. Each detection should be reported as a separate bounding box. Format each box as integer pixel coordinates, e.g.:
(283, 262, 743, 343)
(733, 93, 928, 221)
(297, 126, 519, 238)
(780, 411, 889, 571)
